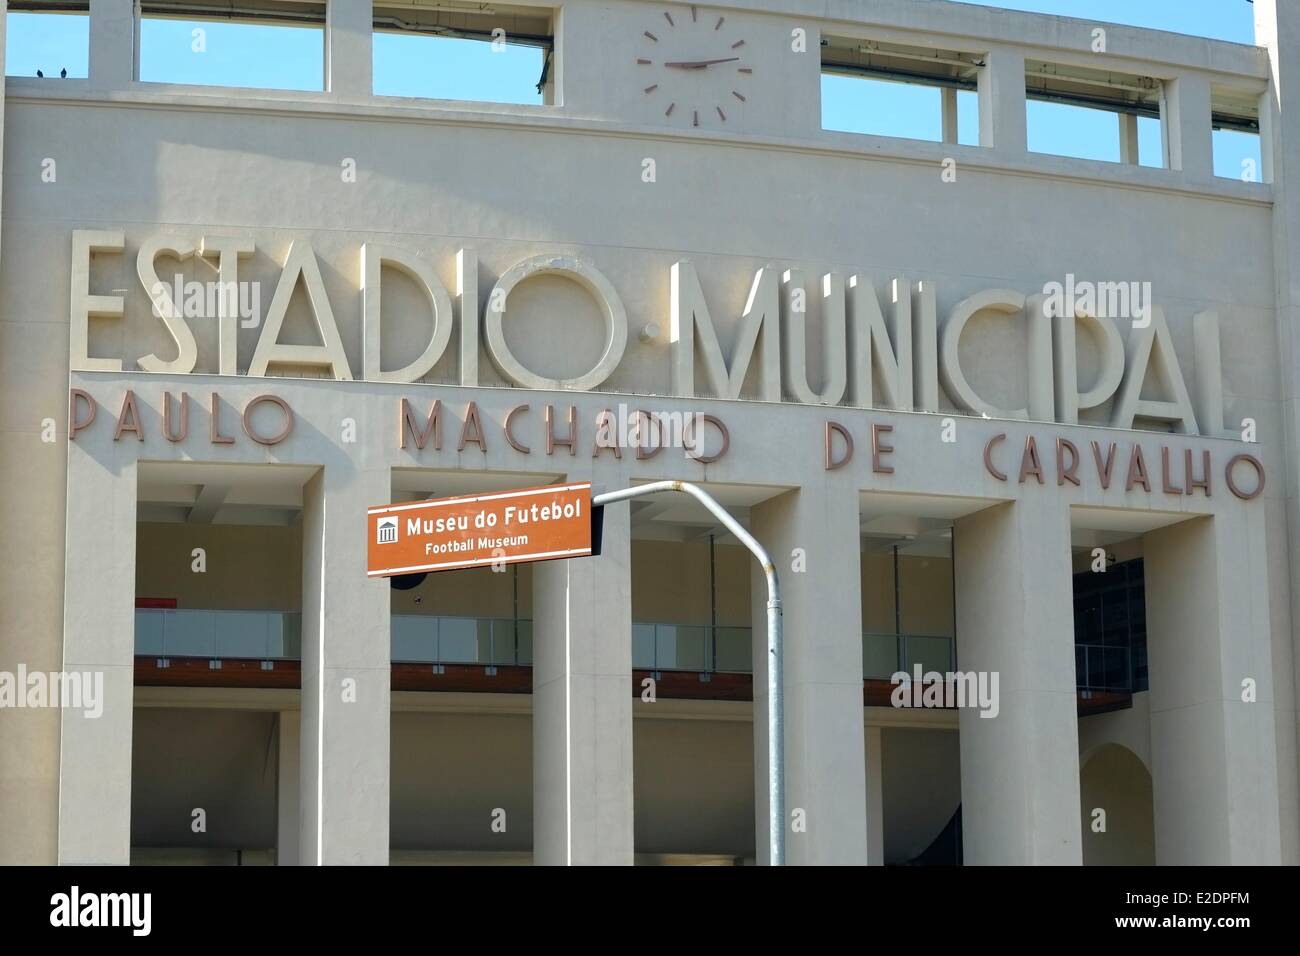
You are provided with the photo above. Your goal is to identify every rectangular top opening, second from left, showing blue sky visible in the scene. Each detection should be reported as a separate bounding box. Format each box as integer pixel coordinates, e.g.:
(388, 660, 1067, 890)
(139, 0, 325, 92)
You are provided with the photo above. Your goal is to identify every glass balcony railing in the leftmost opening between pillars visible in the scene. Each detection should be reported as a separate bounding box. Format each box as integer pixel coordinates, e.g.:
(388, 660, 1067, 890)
(135, 607, 303, 661)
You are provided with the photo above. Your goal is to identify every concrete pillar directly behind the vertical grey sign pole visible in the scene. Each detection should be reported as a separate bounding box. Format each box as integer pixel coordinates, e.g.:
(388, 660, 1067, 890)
(750, 486, 867, 865)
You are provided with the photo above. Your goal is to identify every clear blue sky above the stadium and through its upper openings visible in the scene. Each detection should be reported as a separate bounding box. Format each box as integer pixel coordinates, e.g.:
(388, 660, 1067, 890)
(5, 0, 1258, 177)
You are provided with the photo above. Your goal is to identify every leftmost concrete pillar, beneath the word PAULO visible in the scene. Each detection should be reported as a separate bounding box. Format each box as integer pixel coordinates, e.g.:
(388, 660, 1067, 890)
(57, 452, 137, 866)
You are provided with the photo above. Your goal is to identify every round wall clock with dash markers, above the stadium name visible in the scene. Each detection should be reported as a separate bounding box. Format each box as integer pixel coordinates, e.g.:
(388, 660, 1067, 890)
(637, 7, 754, 127)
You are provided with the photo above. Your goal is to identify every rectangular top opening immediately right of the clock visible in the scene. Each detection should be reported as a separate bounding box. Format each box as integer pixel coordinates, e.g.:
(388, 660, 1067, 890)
(822, 36, 983, 146)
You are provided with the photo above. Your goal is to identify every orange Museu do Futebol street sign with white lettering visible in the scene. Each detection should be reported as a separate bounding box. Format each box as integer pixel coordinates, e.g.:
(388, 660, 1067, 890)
(367, 481, 592, 578)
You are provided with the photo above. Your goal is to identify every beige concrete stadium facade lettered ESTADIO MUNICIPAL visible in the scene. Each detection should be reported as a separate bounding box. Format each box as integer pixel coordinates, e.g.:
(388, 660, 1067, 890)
(0, 0, 1300, 865)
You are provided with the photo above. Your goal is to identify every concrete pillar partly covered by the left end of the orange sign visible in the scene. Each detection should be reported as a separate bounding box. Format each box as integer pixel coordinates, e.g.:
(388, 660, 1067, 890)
(299, 468, 391, 865)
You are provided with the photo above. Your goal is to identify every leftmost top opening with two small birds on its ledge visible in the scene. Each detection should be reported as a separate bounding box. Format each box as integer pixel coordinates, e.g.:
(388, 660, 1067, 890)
(4, 0, 90, 79)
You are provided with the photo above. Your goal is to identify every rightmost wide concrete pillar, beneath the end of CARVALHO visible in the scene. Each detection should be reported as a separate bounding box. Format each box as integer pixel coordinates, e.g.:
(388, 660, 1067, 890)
(1144, 507, 1281, 866)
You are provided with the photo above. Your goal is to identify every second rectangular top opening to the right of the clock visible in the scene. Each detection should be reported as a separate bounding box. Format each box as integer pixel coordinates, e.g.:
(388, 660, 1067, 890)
(1024, 60, 1166, 169)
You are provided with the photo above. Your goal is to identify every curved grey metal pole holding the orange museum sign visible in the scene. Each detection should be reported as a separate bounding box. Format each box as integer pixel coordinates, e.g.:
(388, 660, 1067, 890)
(592, 481, 785, 866)
